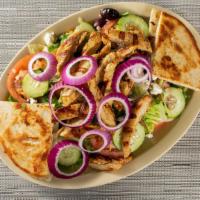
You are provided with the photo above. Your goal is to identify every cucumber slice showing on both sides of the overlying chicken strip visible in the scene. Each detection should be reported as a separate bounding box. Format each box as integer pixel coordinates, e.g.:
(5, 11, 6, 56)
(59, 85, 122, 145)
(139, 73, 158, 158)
(113, 124, 145, 152)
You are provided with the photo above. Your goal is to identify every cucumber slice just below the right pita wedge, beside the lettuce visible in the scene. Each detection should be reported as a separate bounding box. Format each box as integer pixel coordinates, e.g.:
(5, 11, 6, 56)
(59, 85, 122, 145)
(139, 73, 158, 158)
(163, 87, 185, 118)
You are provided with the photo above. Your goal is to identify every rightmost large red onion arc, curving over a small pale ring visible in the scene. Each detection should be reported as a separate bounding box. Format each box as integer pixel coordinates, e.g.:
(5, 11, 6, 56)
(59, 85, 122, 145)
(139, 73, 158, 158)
(112, 59, 151, 92)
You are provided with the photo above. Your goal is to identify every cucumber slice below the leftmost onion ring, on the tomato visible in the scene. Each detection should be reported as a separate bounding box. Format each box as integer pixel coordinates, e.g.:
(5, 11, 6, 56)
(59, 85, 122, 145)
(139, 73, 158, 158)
(22, 74, 49, 98)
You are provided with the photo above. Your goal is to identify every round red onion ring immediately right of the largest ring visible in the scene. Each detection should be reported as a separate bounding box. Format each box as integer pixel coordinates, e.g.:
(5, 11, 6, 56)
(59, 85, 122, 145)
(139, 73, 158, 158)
(97, 93, 131, 131)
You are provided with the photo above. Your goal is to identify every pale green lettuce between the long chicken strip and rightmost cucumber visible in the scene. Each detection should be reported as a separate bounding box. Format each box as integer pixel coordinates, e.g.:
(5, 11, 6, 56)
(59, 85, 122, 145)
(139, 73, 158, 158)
(143, 100, 167, 133)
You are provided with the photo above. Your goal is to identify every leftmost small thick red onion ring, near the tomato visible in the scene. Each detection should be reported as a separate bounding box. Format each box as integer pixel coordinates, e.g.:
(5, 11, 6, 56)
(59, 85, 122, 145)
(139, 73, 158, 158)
(28, 52, 57, 81)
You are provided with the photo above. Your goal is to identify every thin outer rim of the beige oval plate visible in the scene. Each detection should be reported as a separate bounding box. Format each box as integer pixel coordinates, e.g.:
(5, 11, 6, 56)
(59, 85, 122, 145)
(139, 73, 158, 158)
(0, 2, 200, 189)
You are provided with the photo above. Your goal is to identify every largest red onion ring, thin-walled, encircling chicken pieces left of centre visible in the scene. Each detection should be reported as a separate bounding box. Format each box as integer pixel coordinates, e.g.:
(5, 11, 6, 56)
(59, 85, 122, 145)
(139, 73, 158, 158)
(49, 82, 96, 128)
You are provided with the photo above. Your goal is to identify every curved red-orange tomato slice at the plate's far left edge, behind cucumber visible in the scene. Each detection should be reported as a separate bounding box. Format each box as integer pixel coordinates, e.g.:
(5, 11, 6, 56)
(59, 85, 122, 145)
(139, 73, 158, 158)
(6, 55, 33, 103)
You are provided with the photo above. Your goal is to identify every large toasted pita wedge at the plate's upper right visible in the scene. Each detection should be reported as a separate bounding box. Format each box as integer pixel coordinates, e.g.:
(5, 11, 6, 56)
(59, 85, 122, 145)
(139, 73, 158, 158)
(150, 12, 200, 90)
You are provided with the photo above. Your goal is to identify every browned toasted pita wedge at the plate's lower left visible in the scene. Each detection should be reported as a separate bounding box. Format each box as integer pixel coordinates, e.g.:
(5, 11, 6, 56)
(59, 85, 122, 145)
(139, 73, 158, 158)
(0, 101, 52, 178)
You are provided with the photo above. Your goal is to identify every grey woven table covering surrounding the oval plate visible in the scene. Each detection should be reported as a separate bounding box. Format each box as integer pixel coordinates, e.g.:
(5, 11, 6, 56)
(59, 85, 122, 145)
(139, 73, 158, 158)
(0, 0, 200, 200)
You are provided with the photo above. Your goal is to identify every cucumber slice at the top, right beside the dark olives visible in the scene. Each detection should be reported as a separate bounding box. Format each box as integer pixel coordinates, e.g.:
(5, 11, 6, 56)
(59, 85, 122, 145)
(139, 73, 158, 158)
(116, 14, 149, 37)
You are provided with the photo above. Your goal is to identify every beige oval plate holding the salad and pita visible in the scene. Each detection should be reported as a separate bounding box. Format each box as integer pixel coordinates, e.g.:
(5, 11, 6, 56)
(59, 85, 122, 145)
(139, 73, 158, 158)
(0, 2, 200, 189)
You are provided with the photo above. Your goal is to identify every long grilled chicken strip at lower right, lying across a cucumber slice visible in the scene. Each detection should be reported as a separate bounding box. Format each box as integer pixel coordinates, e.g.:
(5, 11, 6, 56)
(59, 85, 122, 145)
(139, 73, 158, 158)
(122, 95, 152, 158)
